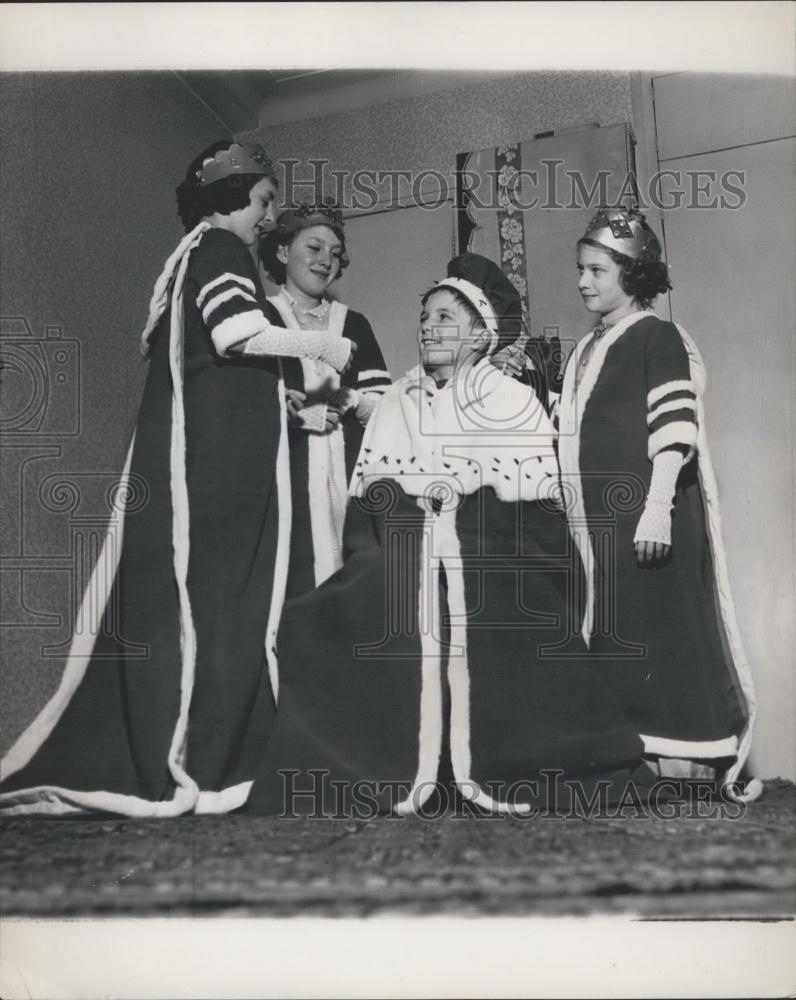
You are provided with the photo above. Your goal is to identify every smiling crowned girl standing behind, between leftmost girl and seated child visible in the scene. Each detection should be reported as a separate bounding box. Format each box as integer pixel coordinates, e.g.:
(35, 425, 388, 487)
(260, 204, 390, 598)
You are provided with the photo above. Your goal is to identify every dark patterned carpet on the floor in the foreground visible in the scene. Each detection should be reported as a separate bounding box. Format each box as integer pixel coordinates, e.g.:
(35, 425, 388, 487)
(0, 781, 796, 918)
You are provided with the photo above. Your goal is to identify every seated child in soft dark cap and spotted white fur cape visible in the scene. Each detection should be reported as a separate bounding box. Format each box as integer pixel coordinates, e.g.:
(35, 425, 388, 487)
(246, 254, 648, 816)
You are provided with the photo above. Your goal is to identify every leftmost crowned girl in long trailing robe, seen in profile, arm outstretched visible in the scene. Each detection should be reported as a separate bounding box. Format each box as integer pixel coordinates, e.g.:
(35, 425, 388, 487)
(2, 137, 351, 816)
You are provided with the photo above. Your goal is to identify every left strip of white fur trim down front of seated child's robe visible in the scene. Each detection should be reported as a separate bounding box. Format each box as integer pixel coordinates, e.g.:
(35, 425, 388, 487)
(394, 514, 442, 815)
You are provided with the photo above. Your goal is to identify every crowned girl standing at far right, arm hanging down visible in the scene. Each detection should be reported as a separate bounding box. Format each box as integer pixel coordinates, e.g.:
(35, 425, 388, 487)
(559, 210, 758, 797)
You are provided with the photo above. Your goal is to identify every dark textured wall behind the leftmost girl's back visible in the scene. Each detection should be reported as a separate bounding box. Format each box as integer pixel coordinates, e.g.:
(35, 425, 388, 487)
(0, 73, 225, 749)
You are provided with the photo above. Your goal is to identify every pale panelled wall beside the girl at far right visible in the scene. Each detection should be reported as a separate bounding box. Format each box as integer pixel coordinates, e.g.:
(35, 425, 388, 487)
(647, 73, 796, 778)
